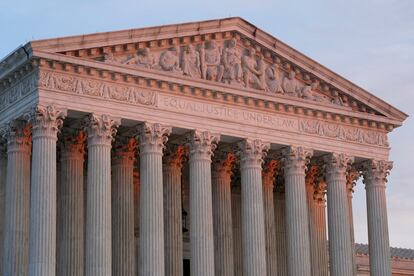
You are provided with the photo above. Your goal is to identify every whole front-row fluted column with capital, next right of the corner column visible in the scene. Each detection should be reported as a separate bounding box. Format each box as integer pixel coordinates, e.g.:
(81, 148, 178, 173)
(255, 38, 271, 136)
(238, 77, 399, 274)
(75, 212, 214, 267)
(85, 114, 119, 276)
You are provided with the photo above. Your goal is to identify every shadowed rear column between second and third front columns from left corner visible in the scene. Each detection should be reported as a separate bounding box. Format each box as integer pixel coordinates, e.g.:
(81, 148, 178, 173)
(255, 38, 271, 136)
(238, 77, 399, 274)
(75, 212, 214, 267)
(111, 136, 137, 276)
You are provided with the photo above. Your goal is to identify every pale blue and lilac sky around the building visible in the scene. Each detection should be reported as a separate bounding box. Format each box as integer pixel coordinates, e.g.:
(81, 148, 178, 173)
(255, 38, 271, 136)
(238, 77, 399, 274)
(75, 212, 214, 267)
(0, 0, 414, 248)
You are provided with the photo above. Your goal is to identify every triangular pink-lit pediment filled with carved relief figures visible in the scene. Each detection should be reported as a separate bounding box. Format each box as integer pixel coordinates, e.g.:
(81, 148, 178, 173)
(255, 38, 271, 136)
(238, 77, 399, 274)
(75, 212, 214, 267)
(0, 18, 407, 126)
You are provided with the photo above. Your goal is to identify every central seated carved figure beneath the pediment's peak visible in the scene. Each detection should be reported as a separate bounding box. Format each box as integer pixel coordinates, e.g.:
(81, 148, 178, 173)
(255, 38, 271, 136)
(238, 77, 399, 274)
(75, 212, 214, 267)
(222, 38, 243, 84)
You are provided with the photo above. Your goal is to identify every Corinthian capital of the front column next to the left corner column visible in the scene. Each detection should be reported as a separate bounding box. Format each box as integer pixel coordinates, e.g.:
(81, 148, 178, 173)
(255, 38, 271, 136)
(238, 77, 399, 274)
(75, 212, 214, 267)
(84, 114, 120, 146)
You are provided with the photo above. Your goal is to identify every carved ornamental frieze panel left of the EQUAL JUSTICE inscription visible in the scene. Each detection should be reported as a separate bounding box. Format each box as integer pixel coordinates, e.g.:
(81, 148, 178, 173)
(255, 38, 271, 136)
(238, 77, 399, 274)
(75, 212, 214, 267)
(39, 71, 157, 106)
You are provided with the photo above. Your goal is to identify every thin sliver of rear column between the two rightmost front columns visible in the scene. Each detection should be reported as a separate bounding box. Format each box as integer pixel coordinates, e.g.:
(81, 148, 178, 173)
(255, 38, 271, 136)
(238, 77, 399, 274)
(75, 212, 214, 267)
(346, 168, 359, 276)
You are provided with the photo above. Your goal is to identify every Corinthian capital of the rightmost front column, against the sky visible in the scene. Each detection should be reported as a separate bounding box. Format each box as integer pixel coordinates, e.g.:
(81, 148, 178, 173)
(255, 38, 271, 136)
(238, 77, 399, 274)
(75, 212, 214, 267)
(362, 160, 393, 186)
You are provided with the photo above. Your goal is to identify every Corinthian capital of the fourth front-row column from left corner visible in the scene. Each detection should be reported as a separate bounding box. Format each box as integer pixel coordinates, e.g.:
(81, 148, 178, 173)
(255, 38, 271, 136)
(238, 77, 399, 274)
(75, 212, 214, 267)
(189, 130, 220, 161)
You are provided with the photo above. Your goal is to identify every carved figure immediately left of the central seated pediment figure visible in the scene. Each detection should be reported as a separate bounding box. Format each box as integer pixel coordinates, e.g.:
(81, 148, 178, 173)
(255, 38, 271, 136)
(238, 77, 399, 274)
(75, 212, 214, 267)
(200, 40, 223, 82)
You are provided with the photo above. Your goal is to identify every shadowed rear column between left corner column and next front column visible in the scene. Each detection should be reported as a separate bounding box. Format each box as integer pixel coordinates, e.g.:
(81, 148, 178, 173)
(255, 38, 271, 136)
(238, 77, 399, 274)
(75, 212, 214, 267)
(57, 131, 86, 276)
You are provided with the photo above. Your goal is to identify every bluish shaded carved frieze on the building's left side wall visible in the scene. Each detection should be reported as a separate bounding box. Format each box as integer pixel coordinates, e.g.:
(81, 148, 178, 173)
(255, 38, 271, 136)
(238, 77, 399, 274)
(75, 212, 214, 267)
(0, 73, 37, 110)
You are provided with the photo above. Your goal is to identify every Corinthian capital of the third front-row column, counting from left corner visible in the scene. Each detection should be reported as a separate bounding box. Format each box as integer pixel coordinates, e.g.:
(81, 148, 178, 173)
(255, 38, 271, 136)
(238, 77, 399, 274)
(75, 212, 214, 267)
(138, 122, 172, 154)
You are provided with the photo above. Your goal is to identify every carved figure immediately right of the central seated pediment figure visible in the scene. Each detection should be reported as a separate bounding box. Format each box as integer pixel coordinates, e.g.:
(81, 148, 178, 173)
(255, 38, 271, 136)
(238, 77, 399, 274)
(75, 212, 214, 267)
(241, 48, 264, 90)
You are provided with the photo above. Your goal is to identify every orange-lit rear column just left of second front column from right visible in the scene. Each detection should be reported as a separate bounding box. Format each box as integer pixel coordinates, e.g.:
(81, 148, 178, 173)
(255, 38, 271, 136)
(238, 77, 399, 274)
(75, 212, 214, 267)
(314, 179, 329, 276)
